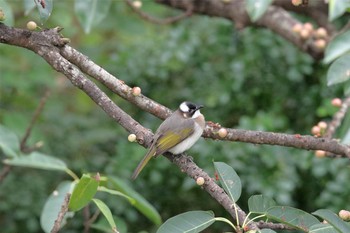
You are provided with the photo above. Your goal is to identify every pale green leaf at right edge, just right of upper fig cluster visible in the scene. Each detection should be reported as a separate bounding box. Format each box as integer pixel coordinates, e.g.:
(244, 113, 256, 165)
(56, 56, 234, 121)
(323, 31, 350, 64)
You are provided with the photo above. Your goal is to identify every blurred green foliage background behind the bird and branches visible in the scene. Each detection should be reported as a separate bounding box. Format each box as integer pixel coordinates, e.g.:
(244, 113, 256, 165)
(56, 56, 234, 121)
(0, 1, 350, 233)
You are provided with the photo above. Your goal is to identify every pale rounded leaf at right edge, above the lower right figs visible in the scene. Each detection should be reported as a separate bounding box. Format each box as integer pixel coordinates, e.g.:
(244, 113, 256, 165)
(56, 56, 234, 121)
(327, 53, 350, 86)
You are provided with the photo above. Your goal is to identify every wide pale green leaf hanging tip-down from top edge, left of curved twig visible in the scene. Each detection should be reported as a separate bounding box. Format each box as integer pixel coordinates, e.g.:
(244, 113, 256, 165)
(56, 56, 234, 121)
(74, 0, 112, 33)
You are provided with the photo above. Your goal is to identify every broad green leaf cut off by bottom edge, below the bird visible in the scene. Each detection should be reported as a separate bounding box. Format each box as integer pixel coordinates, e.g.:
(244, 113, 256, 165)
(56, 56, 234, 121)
(157, 211, 215, 233)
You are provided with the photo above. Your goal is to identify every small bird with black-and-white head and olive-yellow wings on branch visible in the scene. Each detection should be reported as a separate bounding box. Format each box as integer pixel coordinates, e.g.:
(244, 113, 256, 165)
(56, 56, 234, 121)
(131, 101, 205, 180)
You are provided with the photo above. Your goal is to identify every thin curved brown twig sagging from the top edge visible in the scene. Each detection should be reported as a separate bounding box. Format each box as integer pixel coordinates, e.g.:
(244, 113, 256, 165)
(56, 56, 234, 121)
(125, 0, 192, 25)
